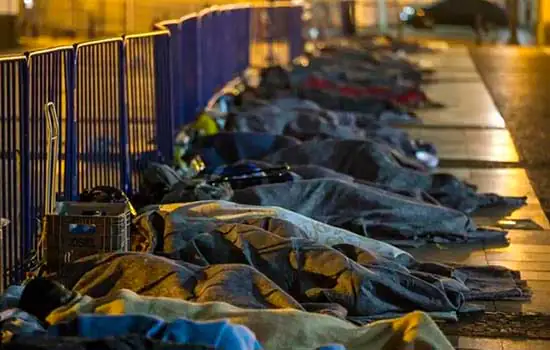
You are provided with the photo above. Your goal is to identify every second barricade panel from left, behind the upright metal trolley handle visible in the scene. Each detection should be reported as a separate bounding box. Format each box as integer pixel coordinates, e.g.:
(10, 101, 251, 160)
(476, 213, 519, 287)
(27, 46, 77, 249)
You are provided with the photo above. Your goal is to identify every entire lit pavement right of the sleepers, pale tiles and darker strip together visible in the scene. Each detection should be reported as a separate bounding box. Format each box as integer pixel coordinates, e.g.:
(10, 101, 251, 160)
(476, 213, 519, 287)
(408, 46, 550, 350)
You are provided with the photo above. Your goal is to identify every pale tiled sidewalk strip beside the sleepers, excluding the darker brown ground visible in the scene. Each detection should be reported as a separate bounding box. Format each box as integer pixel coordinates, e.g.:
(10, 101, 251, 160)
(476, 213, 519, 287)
(409, 47, 550, 350)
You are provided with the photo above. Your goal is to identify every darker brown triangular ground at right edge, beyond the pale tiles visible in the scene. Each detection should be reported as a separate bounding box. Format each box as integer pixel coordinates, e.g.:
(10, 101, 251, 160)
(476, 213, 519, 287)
(472, 47, 550, 217)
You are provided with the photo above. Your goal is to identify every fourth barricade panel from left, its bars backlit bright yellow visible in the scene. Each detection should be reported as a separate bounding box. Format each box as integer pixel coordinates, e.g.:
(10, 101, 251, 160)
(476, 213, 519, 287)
(125, 31, 174, 191)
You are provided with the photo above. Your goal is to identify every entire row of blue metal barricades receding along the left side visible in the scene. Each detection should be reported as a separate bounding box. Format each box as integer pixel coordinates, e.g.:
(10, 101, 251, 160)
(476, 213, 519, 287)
(0, 3, 310, 288)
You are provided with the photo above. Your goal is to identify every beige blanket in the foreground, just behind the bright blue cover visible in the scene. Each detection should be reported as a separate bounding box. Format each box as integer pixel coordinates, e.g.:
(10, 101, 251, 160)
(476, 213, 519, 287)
(48, 290, 453, 350)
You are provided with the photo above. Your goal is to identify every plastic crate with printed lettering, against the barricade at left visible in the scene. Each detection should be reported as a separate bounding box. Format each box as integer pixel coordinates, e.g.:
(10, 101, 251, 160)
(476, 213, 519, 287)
(44, 202, 132, 272)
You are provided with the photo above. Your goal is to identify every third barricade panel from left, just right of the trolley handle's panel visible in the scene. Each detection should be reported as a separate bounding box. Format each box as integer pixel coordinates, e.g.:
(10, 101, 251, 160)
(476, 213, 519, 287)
(74, 38, 132, 193)
